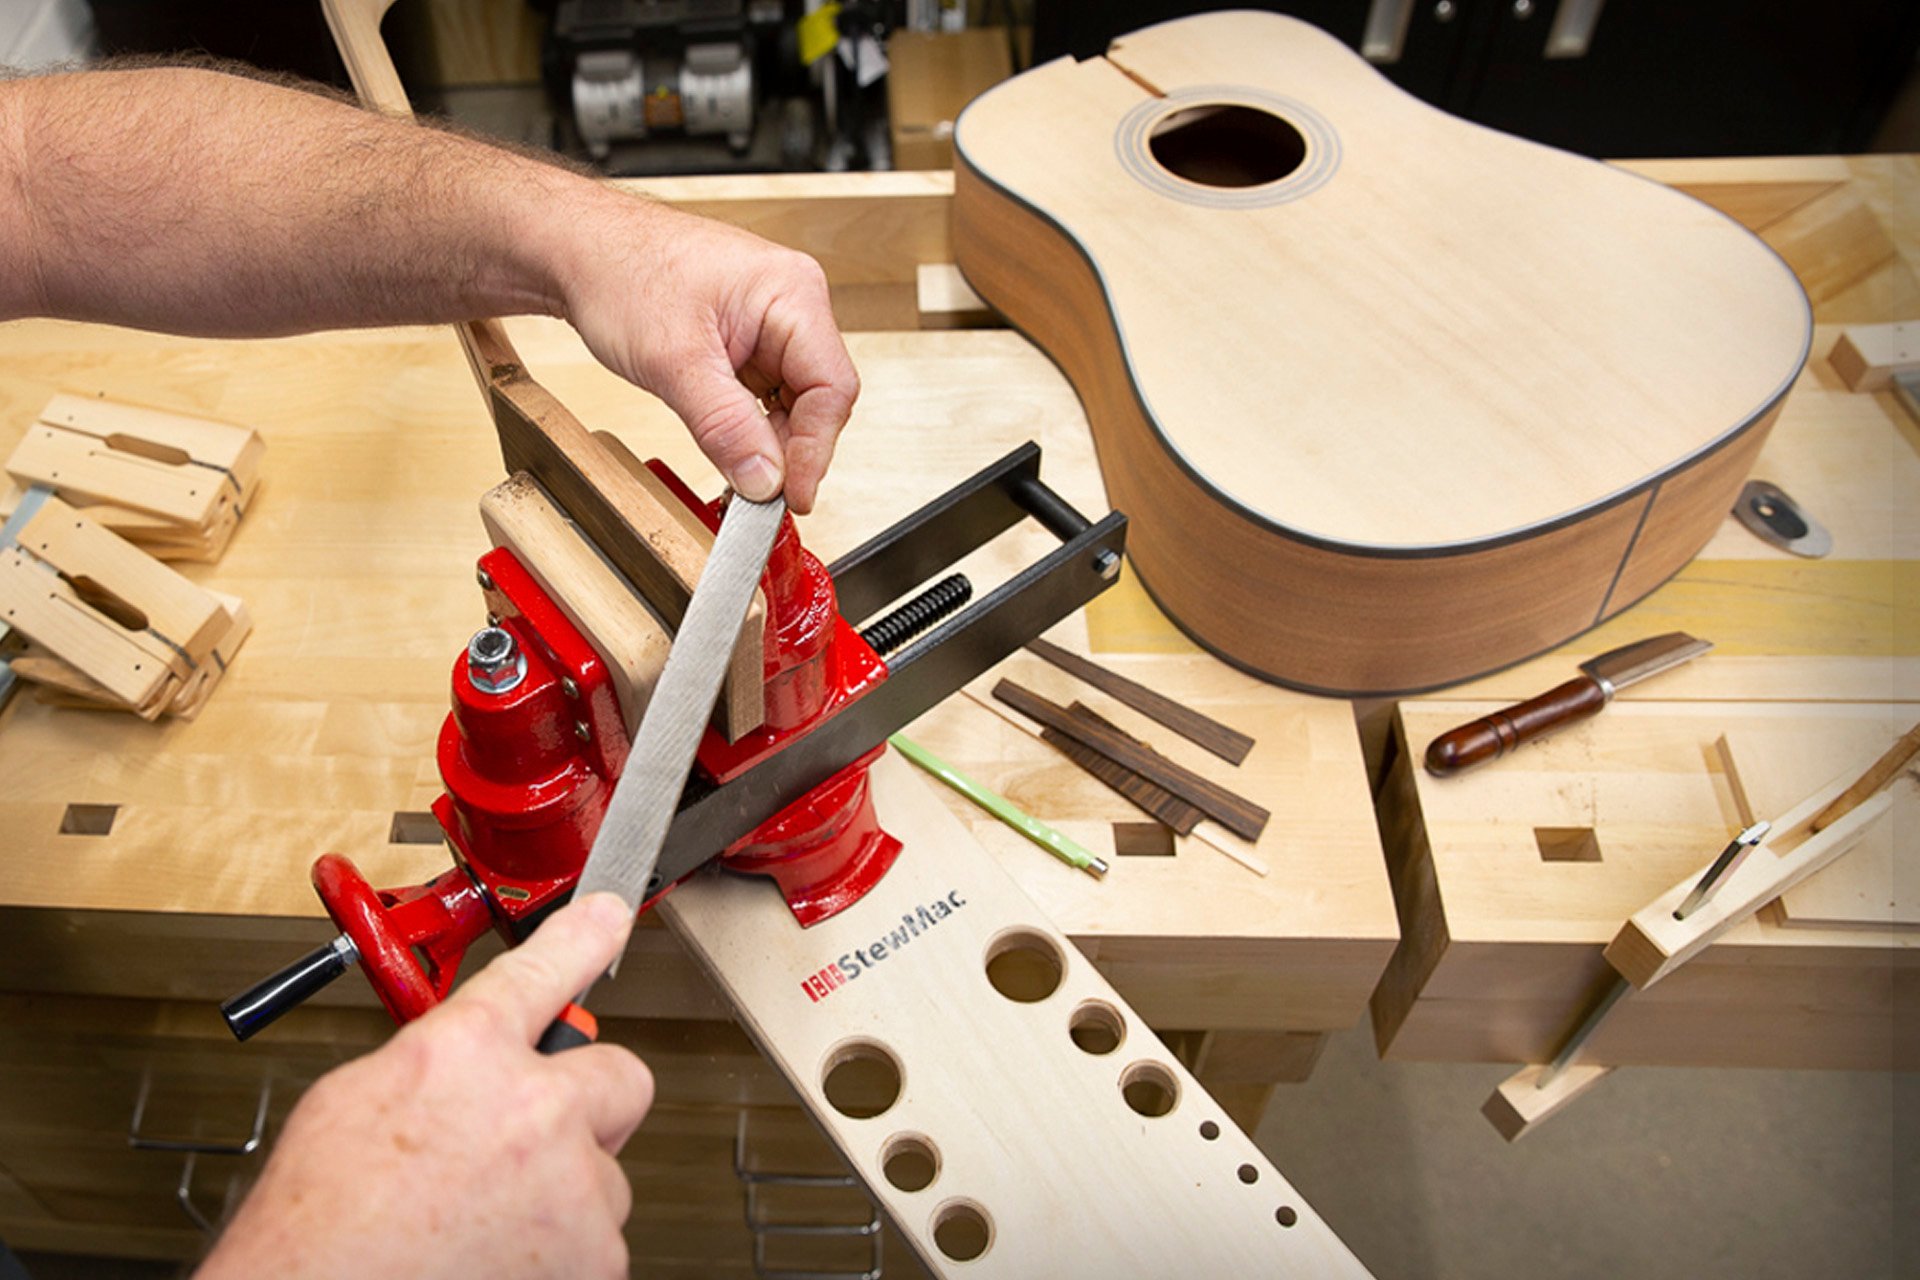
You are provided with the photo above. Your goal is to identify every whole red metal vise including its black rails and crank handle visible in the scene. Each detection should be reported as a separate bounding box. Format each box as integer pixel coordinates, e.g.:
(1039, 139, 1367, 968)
(221, 443, 1127, 1040)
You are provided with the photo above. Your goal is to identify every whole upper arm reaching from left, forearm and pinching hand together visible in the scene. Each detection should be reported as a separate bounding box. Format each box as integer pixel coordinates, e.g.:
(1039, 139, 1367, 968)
(0, 69, 860, 514)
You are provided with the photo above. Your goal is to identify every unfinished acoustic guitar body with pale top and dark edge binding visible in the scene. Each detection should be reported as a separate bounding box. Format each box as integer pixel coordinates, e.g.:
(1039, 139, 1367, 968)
(954, 13, 1812, 695)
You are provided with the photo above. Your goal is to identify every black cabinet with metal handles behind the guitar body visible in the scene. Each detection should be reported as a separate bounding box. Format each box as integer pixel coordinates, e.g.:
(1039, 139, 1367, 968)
(1033, 0, 1920, 157)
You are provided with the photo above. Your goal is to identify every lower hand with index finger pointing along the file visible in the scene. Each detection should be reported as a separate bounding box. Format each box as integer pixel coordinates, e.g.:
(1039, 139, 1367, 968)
(198, 894, 653, 1280)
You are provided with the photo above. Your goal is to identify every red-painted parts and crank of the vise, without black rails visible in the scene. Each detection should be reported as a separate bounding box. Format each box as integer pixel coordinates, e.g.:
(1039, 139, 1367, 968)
(223, 461, 900, 1038)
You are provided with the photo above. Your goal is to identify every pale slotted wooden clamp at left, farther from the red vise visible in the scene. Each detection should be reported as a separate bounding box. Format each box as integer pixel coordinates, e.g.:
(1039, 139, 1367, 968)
(6, 395, 267, 560)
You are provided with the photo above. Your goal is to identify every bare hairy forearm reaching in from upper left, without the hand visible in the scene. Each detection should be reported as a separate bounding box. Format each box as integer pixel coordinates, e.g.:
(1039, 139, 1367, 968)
(0, 69, 614, 336)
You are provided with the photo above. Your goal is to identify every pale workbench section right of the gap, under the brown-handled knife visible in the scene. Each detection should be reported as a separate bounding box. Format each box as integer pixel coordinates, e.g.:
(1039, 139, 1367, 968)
(1365, 157, 1920, 1069)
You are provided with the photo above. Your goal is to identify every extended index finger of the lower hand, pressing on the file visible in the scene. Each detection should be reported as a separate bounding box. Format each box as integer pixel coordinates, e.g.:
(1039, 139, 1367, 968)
(447, 892, 633, 1043)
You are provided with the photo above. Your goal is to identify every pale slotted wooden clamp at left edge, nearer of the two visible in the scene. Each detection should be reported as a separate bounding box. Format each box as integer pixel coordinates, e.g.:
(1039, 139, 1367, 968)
(0, 495, 250, 720)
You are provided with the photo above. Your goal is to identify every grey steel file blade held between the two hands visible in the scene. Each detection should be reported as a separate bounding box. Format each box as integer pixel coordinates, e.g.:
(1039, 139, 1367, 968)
(574, 493, 787, 924)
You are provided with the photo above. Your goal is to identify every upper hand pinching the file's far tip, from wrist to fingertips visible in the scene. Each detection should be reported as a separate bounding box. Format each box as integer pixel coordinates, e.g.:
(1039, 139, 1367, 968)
(561, 192, 860, 514)
